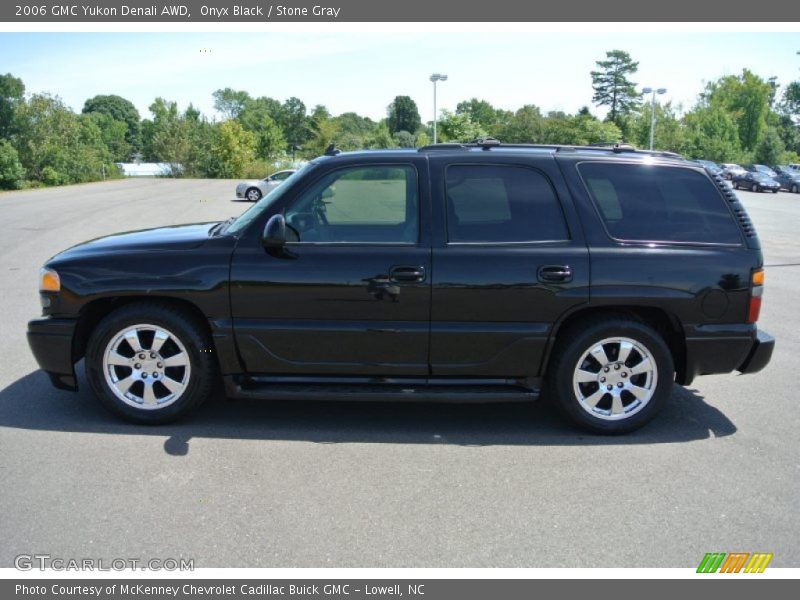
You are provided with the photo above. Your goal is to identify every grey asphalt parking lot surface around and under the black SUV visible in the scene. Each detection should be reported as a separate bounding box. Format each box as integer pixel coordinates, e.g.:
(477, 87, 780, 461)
(0, 180, 800, 567)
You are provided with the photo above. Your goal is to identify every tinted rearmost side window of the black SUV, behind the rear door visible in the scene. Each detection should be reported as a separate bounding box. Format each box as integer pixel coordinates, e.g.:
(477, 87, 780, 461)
(578, 163, 742, 244)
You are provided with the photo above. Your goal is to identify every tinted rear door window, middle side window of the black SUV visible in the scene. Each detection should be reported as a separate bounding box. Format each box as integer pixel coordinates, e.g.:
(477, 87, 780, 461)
(446, 165, 569, 242)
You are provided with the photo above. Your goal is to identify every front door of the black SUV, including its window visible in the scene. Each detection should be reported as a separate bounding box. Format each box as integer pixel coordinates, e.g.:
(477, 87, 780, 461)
(231, 157, 431, 377)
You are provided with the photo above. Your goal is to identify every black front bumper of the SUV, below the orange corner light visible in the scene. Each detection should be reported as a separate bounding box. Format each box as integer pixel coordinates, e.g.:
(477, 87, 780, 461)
(28, 318, 78, 392)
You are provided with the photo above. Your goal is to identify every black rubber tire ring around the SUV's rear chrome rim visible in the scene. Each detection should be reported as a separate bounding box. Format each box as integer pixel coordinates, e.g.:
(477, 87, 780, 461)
(547, 320, 675, 434)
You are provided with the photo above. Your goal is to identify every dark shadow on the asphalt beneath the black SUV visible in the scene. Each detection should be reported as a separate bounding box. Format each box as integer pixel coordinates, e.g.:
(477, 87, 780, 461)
(0, 365, 736, 456)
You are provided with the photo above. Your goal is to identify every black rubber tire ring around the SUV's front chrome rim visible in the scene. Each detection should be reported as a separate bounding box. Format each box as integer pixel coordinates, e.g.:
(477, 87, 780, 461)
(85, 306, 215, 424)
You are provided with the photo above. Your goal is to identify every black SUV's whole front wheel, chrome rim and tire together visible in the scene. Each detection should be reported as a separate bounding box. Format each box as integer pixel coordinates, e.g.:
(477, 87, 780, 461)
(86, 302, 218, 424)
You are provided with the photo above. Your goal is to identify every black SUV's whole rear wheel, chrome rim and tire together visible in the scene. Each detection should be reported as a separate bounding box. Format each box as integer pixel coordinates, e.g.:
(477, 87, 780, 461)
(547, 317, 675, 434)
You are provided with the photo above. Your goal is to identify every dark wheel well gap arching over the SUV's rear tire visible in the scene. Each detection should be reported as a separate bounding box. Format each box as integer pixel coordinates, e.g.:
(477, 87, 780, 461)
(542, 306, 688, 383)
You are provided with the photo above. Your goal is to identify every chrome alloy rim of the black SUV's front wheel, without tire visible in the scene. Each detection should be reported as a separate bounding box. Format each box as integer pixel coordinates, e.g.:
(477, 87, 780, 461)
(103, 324, 192, 410)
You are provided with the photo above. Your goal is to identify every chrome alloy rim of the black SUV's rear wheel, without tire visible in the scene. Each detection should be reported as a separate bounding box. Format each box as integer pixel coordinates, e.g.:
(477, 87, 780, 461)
(572, 337, 658, 421)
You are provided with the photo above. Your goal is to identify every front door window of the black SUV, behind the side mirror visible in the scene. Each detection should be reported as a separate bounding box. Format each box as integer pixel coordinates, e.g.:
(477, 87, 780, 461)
(285, 165, 419, 244)
